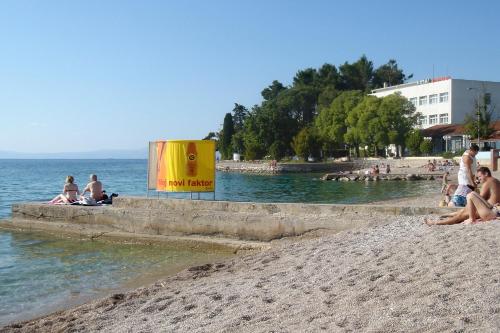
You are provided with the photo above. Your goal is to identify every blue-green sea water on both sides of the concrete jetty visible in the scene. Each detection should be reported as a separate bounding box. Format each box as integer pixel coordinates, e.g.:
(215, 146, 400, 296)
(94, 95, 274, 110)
(0, 159, 436, 327)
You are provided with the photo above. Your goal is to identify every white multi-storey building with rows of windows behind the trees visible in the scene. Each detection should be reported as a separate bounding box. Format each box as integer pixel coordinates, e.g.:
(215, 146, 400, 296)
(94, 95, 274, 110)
(372, 77, 500, 128)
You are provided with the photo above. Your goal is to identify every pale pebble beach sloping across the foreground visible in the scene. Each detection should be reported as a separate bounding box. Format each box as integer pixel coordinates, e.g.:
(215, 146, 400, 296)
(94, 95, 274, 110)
(4, 211, 500, 332)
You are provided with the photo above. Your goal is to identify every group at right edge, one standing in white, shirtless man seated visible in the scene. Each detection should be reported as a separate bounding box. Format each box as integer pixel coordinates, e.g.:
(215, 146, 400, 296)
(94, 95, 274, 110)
(425, 144, 500, 225)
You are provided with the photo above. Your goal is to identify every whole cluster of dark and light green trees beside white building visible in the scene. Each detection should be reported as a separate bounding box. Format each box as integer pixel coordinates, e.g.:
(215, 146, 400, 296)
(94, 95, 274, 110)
(205, 55, 419, 160)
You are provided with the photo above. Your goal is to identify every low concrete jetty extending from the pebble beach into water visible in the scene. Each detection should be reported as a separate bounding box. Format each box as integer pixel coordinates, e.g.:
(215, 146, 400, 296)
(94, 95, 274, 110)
(12, 197, 458, 241)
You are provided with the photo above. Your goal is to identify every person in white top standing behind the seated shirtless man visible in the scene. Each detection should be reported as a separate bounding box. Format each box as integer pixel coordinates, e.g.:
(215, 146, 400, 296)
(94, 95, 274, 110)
(450, 144, 479, 207)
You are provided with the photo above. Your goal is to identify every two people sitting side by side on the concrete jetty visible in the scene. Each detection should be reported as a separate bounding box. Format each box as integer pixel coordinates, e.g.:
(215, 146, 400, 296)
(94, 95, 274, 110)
(49, 174, 108, 204)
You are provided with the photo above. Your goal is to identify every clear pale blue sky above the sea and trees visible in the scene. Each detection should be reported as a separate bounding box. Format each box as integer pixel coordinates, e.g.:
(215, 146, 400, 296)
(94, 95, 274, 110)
(0, 0, 500, 153)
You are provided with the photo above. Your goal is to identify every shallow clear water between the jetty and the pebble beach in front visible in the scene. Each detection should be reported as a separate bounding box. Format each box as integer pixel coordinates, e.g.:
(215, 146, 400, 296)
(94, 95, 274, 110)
(0, 231, 230, 324)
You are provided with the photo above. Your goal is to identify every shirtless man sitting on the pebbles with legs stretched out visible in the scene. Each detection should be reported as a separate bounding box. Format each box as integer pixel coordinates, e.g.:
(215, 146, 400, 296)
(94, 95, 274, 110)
(425, 167, 500, 225)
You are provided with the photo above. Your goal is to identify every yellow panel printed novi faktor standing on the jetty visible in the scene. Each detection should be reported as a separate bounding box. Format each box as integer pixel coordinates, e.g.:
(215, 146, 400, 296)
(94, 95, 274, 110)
(156, 140, 215, 192)
